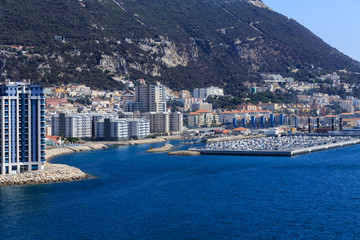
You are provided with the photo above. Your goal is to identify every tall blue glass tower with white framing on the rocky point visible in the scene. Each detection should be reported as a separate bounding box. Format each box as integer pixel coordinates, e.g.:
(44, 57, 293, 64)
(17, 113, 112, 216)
(0, 81, 45, 174)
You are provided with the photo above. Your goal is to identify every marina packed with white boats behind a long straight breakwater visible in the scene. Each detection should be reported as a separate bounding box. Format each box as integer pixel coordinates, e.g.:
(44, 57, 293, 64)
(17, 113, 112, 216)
(191, 136, 360, 157)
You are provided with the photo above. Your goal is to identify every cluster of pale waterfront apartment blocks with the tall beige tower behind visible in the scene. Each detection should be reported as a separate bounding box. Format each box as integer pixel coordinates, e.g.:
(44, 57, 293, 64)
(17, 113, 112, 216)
(51, 80, 183, 141)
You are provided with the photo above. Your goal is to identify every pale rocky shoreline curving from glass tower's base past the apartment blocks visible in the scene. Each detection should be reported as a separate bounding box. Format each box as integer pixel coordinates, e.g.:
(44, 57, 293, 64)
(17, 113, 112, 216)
(0, 136, 181, 187)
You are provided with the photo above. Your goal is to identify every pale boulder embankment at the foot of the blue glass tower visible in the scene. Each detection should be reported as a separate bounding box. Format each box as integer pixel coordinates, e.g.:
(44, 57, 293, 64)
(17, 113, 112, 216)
(0, 163, 91, 186)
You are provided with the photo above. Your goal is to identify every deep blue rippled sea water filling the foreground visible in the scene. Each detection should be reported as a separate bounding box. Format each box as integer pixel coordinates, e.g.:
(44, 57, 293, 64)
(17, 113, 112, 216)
(0, 144, 360, 239)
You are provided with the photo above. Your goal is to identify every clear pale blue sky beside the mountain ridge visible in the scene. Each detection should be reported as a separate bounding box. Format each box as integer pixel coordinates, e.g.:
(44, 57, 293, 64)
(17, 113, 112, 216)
(263, 0, 360, 61)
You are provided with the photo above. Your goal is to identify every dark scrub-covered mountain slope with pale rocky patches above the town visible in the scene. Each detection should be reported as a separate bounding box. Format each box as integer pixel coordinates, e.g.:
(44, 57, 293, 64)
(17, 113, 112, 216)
(0, 0, 360, 94)
